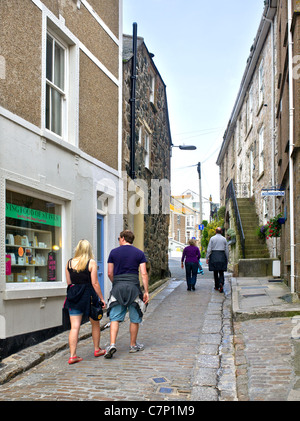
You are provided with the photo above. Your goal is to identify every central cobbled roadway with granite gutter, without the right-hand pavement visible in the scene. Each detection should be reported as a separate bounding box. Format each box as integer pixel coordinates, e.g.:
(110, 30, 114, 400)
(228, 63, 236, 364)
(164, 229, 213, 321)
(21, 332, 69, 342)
(0, 260, 233, 401)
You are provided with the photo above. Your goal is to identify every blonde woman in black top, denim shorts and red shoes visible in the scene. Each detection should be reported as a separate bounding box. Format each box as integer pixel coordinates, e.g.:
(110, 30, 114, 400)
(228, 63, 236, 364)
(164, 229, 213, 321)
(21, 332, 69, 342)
(65, 240, 106, 364)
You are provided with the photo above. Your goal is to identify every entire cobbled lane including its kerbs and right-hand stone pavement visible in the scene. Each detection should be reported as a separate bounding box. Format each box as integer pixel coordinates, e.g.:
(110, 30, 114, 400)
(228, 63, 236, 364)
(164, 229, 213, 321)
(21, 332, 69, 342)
(0, 259, 300, 403)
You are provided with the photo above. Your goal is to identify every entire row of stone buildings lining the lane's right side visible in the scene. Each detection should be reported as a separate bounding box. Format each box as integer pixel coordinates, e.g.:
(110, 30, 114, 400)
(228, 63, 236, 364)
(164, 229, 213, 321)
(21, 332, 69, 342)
(217, 0, 300, 294)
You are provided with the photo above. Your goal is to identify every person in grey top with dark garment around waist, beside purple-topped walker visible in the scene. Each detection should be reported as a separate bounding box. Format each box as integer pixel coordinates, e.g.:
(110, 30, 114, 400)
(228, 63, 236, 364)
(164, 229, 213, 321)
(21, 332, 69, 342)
(206, 227, 229, 292)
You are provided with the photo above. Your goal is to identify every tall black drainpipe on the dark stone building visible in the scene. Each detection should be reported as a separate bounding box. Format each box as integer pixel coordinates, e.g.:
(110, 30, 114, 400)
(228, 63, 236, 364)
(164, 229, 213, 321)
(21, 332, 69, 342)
(130, 23, 137, 180)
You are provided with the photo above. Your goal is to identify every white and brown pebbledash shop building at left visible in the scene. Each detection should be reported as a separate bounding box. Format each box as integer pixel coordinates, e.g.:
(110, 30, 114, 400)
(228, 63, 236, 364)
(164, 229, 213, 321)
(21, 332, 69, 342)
(0, 0, 123, 357)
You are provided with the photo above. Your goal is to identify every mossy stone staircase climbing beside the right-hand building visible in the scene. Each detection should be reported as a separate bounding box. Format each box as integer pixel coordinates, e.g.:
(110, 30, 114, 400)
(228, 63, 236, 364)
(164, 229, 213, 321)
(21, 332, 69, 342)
(237, 198, 273, 277)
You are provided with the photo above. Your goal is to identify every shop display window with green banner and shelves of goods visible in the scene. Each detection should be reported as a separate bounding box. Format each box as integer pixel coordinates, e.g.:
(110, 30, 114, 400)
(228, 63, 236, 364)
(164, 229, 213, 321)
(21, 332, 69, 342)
(5, 190, 62, 282)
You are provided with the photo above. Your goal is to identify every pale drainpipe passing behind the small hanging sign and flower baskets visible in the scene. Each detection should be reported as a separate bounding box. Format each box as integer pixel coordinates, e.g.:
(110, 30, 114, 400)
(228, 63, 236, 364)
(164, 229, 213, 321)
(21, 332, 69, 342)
(263, 17, 277, 257)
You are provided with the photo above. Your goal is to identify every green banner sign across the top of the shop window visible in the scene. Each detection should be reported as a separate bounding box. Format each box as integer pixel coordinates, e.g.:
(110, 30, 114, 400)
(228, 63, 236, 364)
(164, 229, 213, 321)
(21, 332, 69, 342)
(6, 203, 61, 227)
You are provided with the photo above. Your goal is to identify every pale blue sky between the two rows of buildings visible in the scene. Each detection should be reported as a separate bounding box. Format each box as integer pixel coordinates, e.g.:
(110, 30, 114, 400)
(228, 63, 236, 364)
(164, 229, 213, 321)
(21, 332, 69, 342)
(123, 0, 264, 203)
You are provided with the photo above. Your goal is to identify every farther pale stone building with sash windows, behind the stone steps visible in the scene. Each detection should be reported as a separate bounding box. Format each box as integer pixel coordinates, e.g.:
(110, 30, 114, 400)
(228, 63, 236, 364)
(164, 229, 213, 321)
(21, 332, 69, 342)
(217, 1, 278, 246)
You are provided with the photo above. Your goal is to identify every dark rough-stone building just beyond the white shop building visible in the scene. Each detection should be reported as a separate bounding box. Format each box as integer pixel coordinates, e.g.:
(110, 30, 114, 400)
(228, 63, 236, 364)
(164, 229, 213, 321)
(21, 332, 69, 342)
(123, 35, 172, 283)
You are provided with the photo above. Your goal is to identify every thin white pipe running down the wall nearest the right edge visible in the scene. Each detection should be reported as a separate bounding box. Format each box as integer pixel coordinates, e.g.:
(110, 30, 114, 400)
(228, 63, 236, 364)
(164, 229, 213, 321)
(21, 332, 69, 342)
(288, 0, 295, 294)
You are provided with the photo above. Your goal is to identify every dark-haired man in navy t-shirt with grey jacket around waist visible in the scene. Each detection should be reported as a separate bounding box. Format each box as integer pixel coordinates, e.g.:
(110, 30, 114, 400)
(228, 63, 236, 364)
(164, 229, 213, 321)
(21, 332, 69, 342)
(105, 230, 149, 358)
